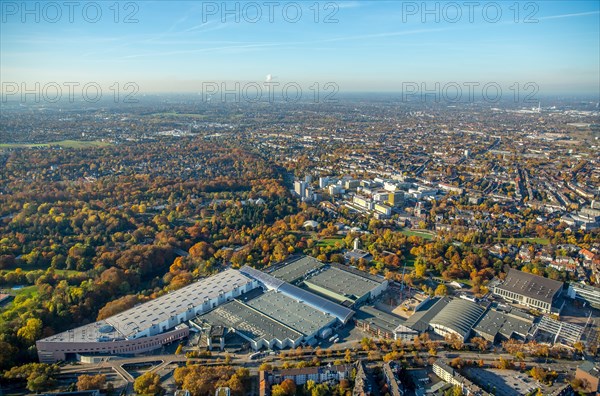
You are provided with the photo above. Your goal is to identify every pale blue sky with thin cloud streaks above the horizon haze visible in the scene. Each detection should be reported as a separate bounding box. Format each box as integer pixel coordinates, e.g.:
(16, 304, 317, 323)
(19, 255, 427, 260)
(0, 0, 600, 94)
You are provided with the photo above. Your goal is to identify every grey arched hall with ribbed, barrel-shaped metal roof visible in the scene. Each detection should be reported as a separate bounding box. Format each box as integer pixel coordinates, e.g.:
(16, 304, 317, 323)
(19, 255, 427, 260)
(431, 299, 485, 337)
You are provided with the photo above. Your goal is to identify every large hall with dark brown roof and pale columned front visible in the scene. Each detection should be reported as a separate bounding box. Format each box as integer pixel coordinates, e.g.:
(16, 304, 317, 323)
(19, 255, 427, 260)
(494, 268, 563, 313)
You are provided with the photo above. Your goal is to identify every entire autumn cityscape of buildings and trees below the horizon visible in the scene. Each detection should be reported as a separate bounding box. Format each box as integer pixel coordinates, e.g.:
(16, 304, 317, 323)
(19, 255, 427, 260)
(0, 94, 600, 396)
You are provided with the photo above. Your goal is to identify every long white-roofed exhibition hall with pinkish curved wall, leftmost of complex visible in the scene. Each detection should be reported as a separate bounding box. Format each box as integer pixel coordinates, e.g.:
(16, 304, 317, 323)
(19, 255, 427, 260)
(36, 269, 259, 363)
